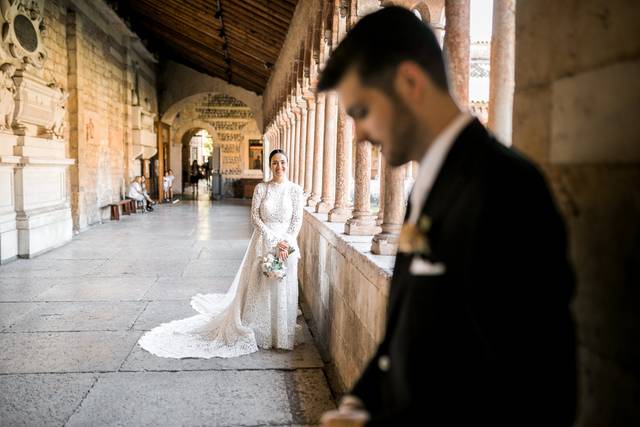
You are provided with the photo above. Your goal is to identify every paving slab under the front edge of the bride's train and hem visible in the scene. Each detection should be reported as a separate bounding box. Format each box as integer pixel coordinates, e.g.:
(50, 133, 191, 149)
(122, 320, 324, 371)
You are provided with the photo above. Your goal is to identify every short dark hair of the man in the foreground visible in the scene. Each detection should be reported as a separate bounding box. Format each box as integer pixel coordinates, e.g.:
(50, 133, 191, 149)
(318, 6, 448, 94)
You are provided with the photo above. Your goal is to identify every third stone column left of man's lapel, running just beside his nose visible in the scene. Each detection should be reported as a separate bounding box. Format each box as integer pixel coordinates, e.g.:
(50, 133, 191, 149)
(329, 103, 353, 222)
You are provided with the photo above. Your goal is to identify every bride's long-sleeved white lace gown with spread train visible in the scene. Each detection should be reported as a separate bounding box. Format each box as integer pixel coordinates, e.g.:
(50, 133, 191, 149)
(138, 181, 303, 358)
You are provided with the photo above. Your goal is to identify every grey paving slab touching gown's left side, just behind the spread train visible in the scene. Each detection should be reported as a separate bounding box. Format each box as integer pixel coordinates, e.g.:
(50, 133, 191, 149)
(144, 276, 233, 300)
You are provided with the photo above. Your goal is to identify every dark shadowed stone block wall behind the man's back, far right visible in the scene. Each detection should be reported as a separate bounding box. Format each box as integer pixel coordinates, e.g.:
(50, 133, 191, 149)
(513, 0, 640, 427)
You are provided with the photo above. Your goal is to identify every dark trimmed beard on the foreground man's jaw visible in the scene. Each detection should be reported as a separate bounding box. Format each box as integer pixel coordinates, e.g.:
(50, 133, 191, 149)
(385, 96, 422, 167)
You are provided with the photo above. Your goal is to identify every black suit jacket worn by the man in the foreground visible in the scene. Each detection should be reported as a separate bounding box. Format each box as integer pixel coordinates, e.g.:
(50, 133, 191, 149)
(352, 120, 576, 426)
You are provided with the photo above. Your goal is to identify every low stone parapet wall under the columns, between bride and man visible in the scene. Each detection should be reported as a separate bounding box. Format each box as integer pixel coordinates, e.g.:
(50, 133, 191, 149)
(298, 208, 394, 393)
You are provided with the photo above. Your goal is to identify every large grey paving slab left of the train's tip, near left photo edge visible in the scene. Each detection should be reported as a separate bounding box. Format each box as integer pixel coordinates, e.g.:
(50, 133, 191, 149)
(5, 301, 147, 332)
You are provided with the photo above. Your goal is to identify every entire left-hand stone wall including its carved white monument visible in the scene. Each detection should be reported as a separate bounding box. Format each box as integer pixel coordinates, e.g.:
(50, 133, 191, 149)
(0, 0, 157, 262)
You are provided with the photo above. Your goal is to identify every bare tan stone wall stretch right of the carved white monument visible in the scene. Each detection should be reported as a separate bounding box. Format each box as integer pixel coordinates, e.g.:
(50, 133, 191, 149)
(61, 0, 157, 230)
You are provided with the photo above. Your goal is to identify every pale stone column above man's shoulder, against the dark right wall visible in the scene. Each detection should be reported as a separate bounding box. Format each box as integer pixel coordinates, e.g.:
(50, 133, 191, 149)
(488, 0, 516, 145)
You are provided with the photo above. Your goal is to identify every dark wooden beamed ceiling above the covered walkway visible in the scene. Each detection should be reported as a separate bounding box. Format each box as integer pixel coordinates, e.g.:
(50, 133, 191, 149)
(118, 0, 297, 94)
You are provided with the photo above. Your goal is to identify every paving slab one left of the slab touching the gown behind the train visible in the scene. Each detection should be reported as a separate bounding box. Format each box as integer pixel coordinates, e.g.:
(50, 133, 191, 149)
(37, 276, 157, 301)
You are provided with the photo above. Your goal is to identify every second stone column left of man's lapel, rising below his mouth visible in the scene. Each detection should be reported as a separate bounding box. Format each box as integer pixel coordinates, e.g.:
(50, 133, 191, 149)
(344, 141, 380, 236)
